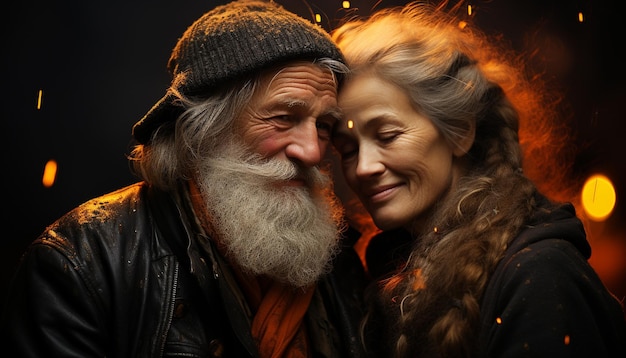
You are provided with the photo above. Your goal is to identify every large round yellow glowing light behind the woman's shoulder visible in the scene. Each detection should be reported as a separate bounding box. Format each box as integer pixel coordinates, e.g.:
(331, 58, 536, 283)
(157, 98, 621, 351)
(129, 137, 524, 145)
(581, 174, 617, 221)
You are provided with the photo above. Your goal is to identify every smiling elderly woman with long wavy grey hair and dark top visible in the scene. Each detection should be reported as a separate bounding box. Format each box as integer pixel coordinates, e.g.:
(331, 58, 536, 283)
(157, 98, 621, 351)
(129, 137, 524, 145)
(333, 3, 626, 357)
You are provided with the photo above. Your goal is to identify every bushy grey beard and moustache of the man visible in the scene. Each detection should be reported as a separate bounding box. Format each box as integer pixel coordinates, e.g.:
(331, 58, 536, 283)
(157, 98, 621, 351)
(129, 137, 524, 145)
(197, 146, 344, 287)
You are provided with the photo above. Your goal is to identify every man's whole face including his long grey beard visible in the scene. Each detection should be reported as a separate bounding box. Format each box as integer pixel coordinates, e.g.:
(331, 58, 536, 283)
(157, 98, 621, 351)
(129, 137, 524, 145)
(197, 63, 343, 287)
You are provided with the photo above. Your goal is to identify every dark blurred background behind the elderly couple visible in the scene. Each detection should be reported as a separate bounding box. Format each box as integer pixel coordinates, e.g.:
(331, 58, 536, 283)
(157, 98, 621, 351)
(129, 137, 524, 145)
(0, 0, 626, 304)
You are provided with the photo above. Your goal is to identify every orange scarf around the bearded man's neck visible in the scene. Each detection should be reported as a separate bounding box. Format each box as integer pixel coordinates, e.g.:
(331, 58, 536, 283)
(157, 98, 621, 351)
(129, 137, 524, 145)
(189, 181, 315, 358)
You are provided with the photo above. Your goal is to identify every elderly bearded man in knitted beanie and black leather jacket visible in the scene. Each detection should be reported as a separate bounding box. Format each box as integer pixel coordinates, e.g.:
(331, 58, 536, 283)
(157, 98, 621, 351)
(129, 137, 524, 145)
(0, 1, 361, 357)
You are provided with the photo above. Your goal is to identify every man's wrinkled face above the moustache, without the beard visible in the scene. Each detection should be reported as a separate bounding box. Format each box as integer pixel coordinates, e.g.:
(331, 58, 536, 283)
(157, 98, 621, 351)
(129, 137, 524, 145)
(238, 63, 339, 176)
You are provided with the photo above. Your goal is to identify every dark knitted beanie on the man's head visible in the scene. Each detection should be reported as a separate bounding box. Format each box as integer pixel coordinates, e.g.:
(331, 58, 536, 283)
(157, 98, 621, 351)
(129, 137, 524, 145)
(133, 0, 345, 144)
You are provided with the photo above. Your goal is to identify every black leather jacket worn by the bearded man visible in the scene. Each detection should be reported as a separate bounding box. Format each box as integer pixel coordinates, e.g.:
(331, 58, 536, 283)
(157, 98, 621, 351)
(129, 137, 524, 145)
(0, 183, 363, 357)
